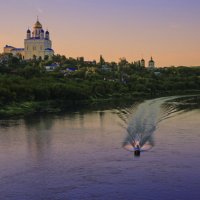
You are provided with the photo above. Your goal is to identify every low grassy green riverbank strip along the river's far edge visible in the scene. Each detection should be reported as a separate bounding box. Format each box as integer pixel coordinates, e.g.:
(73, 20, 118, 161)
(0, 91, 200, 119)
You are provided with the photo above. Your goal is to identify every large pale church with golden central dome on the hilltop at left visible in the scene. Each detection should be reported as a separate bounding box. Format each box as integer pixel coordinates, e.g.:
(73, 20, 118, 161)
(4, 19, 54, 60)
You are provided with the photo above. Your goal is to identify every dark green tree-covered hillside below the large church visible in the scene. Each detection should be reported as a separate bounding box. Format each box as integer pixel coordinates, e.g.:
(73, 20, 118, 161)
(0, 54, 200, 106)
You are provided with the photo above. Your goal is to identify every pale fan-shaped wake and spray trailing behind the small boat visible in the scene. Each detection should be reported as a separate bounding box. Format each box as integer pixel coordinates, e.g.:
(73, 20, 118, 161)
(118, 97, 191, 151)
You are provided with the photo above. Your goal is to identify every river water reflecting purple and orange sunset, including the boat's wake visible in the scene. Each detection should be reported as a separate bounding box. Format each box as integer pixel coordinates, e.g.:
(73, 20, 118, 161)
(0, 97, 200, 200)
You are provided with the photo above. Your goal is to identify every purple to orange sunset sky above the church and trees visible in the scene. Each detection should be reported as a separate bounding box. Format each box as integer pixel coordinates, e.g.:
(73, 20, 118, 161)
(0, 0, 200, 67)
